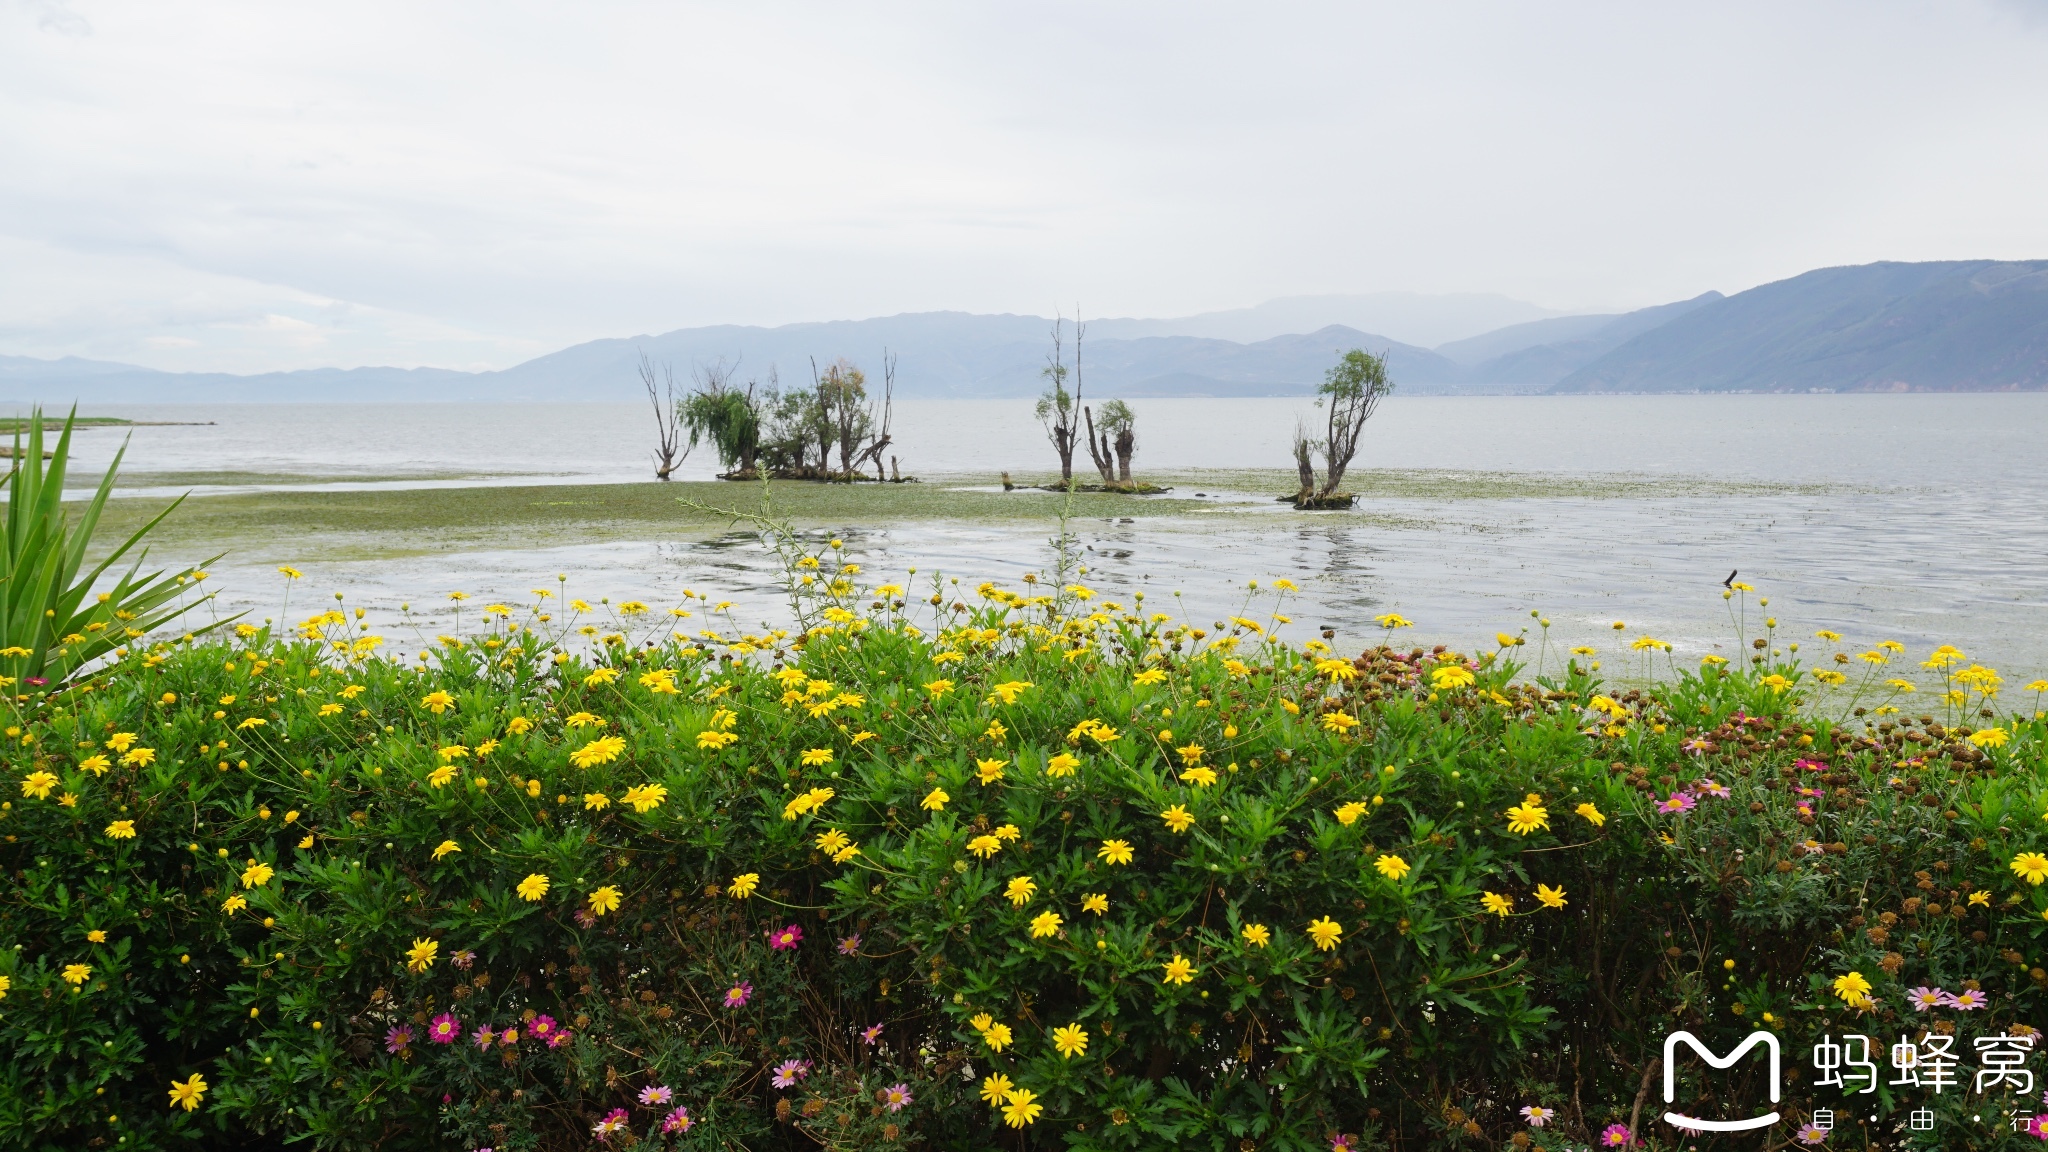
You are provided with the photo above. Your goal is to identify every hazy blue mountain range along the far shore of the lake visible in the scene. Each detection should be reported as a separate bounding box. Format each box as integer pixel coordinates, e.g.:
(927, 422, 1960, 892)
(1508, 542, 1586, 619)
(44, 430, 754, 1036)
(0, 260, 2048, 408)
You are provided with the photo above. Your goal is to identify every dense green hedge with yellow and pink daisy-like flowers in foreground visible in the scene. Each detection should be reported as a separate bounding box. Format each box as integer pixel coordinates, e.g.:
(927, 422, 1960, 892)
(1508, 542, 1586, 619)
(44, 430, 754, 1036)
(0, 553, 2048, 1150)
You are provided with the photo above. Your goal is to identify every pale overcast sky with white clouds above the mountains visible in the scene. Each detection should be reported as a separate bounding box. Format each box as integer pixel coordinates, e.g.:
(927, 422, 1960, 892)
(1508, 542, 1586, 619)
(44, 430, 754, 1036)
(0, 0, 2048, 373)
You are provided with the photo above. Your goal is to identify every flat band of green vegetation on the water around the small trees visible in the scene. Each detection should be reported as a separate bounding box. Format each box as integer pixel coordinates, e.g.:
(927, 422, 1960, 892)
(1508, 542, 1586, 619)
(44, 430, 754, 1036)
(92, 461, 1859, 560)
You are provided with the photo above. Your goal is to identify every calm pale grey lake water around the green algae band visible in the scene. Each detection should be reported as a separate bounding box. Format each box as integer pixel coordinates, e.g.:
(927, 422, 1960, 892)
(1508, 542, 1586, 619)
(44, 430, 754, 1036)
(51, 394, 2048, 680)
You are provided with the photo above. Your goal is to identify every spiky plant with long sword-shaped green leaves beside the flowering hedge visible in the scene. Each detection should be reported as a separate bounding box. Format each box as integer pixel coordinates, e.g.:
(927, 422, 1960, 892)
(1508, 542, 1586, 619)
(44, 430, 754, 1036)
(0, 408, 219, 687)
